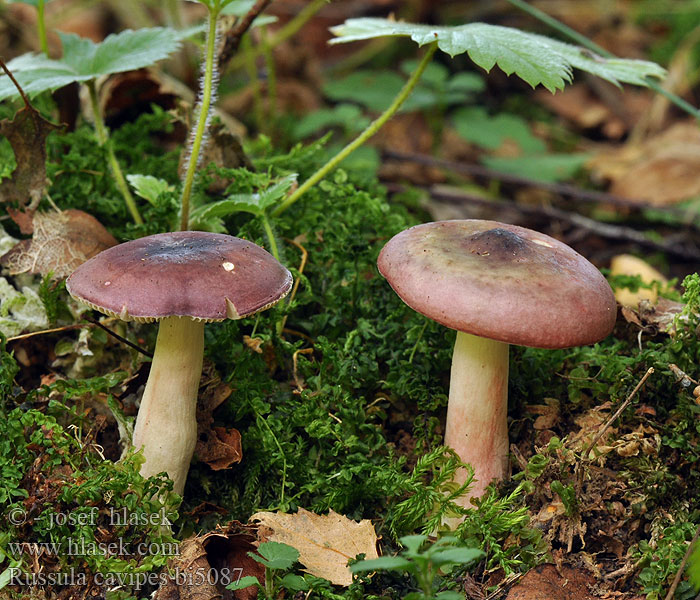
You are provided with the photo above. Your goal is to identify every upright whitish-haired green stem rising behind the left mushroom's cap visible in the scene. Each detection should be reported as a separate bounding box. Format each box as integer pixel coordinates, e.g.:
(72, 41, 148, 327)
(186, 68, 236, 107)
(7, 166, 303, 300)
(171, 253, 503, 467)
(180, 8, 219, 231)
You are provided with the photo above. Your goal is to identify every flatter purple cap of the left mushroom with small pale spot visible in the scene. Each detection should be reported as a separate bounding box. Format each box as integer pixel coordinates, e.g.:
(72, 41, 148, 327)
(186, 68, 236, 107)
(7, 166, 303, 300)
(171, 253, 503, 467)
(66, 231, 292, 321)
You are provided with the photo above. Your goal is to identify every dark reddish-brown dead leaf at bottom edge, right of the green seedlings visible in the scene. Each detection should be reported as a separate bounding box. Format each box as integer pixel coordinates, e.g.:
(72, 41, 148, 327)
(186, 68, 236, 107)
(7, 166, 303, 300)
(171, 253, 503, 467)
(506, 564, 595, 600)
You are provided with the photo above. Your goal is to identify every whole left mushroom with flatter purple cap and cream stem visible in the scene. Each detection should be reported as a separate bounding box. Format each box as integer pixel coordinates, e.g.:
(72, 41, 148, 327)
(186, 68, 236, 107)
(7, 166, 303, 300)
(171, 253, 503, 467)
(66, 231, 292, 495)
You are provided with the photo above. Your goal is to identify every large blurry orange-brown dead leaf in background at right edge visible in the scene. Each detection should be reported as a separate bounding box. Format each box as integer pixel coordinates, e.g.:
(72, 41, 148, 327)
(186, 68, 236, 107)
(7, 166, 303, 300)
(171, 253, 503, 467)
(589, 121, 700, 206)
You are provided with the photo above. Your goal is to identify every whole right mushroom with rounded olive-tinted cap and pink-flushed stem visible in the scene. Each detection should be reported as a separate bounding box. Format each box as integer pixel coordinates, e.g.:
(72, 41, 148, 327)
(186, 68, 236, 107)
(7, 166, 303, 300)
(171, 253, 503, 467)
(377, 220, 617, 507)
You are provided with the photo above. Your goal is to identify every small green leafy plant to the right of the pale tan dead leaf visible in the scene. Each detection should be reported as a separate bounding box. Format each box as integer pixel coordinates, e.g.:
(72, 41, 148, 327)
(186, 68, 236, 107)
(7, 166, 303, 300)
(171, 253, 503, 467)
(350, 535, 484, 600)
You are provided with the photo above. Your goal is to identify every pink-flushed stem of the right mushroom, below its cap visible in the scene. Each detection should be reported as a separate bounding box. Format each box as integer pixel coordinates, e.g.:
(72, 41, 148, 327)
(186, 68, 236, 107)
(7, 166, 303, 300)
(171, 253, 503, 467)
(445, 331, 509, 507)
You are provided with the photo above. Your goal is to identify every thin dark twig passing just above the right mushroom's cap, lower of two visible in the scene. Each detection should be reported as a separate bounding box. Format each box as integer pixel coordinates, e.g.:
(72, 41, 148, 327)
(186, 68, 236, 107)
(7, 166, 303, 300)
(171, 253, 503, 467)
(429, 185, 700, 260)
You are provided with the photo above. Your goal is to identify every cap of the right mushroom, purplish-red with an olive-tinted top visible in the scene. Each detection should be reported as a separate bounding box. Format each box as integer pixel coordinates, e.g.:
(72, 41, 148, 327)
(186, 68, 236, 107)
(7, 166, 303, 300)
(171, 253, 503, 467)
(377, 220, 617, 348)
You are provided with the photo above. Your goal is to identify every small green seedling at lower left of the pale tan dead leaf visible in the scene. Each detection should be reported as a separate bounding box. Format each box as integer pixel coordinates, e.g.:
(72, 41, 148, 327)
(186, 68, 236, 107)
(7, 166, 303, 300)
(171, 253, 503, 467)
(226, 542, 300, 600)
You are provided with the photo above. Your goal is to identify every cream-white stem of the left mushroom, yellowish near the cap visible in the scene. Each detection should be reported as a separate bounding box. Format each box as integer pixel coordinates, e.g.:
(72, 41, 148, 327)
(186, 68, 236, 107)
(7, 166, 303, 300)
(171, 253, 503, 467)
(133, 317, 204, 495)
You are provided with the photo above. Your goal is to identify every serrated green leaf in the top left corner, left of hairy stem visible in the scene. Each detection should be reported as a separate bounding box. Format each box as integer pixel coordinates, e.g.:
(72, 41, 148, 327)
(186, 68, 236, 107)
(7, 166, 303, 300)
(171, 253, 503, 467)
(0, 27, 181, 100)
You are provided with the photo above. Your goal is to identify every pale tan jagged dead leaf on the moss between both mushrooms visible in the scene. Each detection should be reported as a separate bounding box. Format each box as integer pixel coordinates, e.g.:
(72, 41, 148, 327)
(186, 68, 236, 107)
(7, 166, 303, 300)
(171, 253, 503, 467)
(250, 508, 378, 586)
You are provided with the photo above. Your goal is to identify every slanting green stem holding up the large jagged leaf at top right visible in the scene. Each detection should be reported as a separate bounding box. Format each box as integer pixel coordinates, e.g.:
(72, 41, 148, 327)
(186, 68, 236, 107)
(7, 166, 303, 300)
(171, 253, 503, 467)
(272, 42, 437, 217)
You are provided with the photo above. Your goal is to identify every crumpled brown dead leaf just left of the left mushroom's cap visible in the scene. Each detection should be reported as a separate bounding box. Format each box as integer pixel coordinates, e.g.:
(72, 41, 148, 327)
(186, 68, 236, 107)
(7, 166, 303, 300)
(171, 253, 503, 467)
(0, 209, 117, 279)
